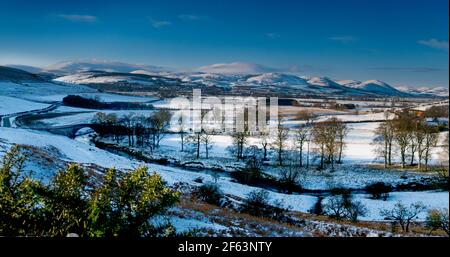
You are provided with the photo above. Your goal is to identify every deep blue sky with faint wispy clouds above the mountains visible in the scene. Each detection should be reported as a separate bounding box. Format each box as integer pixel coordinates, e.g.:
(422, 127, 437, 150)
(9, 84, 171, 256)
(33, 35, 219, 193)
(0, 0, 449, 87)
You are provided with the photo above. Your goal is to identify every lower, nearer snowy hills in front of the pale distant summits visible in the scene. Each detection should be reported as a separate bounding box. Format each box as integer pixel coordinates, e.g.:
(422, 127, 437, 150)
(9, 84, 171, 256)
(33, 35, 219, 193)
(55, 70, 448, 97)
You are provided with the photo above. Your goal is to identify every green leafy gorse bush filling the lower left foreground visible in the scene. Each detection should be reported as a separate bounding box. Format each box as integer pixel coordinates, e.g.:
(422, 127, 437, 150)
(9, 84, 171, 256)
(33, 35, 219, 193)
(0, 146, 179, 237)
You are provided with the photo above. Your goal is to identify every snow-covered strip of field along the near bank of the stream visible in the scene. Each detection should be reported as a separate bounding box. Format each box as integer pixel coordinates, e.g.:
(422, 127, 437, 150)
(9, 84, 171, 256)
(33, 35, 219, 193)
(0, 128, 449, 220)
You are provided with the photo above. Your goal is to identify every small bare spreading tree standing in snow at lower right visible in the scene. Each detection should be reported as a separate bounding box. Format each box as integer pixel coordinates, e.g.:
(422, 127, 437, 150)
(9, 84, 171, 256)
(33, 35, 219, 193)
(380, 201, 425, 232)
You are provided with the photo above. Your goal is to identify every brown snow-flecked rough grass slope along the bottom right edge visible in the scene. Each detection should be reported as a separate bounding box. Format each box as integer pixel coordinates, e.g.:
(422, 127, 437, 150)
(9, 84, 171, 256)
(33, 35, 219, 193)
(172, 195, 447, 237)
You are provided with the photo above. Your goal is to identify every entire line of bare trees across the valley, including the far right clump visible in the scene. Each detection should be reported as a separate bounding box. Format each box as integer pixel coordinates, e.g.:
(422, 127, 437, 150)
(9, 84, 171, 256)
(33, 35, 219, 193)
(94, 106, 448, 174)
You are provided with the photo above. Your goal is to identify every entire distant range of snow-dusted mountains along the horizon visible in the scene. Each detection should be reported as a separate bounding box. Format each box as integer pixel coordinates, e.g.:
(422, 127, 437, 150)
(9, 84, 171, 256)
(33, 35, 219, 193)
(0, 61, 449, 97)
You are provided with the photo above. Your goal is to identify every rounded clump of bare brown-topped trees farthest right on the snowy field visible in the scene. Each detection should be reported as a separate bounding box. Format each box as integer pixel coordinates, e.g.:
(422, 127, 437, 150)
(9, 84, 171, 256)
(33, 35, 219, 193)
(374, 109, 448, 170)
